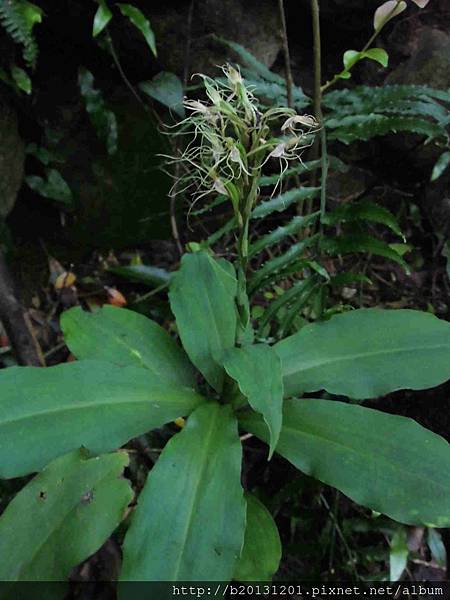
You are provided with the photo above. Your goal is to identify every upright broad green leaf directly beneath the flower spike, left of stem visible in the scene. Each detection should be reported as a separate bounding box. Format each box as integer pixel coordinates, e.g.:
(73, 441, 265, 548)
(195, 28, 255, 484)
(169, 251, 237, 392)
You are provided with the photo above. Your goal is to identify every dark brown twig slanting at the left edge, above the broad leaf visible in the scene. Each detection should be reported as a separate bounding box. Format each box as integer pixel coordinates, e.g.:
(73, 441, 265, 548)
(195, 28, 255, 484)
(0, 250, 45, 367)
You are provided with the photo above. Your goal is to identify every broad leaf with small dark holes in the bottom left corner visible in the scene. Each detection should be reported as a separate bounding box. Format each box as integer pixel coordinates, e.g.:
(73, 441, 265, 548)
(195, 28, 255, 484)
(0, 450, 133, 581)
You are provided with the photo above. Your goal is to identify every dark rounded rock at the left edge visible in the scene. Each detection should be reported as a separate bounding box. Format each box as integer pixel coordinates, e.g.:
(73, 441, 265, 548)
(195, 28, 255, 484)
(0, 98, 25, 220)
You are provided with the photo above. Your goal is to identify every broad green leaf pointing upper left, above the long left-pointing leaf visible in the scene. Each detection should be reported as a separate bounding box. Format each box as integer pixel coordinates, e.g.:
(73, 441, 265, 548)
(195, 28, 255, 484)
(61, 305, 195, 387)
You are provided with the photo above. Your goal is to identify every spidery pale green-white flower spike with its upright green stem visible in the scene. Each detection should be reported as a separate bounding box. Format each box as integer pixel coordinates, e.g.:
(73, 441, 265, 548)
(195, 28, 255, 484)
(166, 65, 319, 338)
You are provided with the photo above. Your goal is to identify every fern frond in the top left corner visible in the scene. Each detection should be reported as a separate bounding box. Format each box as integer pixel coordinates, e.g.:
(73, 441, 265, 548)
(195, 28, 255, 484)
(0, 0, 42, 68)
